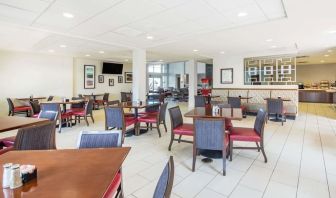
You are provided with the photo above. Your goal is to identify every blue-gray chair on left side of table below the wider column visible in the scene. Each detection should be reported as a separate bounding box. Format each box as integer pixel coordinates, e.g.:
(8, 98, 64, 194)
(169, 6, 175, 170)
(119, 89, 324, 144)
(105, 106, 138, 142)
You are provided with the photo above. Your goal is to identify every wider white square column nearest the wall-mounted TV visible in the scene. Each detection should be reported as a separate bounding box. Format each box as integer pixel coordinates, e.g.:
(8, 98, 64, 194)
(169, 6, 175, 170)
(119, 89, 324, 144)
(132, 49, 147, 101)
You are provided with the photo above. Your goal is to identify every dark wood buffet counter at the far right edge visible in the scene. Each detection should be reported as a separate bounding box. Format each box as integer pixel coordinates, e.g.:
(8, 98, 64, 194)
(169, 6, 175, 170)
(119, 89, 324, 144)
(299, 89, 336, 103)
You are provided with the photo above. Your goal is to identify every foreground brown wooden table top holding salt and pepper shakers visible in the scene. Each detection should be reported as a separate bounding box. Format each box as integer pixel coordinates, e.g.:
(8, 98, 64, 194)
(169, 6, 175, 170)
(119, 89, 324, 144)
(0, 147, 131, 198)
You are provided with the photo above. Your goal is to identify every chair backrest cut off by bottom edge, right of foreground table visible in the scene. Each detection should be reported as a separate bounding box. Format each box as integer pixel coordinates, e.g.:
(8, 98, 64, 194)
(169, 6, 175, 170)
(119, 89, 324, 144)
(153, 156, 174, 198)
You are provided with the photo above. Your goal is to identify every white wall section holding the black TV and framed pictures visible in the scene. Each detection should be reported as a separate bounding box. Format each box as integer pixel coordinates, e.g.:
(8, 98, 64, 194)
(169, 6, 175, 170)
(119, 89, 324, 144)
(73, 58, 133, 100)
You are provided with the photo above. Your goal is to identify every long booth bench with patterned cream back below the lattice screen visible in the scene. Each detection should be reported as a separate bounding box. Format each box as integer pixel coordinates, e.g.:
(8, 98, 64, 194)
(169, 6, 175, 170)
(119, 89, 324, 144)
(212, 88, 299, 118)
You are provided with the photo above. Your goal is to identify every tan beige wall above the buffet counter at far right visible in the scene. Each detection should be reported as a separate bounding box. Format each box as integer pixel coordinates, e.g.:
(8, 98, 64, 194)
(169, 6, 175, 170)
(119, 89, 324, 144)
(297, 64, 336, 83)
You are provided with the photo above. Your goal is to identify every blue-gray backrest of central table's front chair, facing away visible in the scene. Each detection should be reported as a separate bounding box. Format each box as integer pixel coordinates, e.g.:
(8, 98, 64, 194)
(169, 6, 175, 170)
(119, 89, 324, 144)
(194, 118, 225, 150)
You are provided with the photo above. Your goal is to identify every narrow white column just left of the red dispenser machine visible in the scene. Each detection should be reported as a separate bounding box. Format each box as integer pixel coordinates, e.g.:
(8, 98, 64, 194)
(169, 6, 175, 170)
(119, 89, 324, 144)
(186, 60, 197, 109)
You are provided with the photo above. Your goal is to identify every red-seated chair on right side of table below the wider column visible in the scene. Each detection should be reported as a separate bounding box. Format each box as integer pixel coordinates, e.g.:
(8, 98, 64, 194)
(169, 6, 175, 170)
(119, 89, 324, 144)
(137, 103, 168, 137)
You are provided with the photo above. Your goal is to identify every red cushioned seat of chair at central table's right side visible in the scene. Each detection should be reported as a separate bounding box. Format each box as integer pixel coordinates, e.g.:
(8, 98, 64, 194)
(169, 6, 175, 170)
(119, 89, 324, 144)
(230, 127, 261, 142)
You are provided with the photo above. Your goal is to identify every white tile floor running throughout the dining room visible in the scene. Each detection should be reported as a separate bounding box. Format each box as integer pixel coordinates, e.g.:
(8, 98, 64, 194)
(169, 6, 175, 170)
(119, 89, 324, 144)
(0, 103, 336, 198)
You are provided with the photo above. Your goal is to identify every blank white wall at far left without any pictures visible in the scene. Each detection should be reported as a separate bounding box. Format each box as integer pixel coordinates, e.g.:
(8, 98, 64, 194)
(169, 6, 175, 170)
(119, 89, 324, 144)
(0, 51, 73, 115)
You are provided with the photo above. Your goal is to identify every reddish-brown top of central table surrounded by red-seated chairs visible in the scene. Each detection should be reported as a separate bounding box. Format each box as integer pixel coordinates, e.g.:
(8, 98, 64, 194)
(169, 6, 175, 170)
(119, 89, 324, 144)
(184, 107, 243, 120)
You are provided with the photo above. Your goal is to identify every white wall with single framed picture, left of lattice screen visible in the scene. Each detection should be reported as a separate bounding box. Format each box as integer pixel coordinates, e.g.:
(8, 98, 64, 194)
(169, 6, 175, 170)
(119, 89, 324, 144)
(213, 55, 297, 89)
